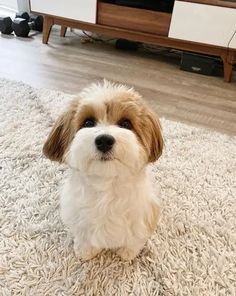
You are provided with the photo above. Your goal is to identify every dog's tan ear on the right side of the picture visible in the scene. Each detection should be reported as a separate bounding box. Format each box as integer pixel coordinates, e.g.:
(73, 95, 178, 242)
(143, 110, 164, 162)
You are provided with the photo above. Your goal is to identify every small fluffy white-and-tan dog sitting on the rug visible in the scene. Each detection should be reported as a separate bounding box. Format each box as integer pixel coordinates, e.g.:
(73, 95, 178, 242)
(43, 81, 163, 260)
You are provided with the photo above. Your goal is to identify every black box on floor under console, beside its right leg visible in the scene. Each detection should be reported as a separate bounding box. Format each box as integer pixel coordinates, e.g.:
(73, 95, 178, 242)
(180, 52, 223, 76)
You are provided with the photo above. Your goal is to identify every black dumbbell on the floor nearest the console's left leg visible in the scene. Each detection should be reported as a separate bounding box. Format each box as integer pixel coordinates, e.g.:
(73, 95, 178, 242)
(12, 15, 43, 37)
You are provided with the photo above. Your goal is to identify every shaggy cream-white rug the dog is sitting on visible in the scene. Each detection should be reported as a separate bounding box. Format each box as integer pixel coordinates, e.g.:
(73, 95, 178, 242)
(0, 80, 236, 296)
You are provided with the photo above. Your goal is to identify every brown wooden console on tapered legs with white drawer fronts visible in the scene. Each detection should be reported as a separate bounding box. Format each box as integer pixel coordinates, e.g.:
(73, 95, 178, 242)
(30, 0, 236, 82)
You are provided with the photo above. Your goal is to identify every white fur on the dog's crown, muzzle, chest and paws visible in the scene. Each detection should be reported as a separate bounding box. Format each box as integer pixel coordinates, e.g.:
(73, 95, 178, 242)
(58, 84, 158, 260)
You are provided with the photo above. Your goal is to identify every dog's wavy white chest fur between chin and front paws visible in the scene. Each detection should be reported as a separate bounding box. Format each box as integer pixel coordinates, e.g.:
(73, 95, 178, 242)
(61, 172, 152, 248)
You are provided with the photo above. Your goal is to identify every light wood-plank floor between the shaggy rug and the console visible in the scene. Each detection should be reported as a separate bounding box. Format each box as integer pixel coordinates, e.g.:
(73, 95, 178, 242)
(0, 30, 236, 134)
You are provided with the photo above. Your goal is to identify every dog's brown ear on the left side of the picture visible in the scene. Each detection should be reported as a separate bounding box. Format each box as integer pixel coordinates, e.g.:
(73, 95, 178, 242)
(43, 100, 78, 162)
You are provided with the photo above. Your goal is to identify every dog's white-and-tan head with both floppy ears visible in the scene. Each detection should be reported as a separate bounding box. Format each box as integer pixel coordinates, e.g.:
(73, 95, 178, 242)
(43, 81, 163, 176)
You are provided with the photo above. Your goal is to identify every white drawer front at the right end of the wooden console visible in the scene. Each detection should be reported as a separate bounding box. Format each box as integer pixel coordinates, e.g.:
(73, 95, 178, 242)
(169, 1, 236, 47)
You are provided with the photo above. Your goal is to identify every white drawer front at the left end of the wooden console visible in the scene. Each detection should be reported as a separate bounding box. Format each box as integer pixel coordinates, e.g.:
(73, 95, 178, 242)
(30, 0, 97, 23)
